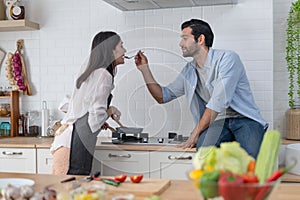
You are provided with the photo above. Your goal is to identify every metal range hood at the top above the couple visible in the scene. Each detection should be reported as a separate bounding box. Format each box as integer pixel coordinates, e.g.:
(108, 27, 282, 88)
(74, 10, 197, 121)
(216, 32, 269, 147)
(104, 0, 238, 11)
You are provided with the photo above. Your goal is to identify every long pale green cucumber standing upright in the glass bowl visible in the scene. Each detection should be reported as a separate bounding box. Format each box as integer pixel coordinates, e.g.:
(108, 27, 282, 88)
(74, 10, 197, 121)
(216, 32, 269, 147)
(254, 130, 281, 183)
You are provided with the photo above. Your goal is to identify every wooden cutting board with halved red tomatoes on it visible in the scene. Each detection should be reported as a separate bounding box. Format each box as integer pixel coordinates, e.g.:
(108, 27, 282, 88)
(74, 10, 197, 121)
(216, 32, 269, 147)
(107, 179, 171, 197)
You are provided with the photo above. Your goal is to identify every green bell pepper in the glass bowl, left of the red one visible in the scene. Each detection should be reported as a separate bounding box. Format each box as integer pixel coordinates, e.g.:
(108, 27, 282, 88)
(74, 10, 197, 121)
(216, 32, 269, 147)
(200, 170, 220, 198)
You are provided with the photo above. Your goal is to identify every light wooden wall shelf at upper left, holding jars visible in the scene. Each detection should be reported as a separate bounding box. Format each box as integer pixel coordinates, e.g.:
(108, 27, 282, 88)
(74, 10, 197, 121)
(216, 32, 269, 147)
(0, 19, 40, 32)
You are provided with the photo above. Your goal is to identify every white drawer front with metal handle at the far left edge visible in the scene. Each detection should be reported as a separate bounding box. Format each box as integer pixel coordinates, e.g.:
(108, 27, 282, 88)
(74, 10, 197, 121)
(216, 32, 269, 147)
(0, 148, 36, 173)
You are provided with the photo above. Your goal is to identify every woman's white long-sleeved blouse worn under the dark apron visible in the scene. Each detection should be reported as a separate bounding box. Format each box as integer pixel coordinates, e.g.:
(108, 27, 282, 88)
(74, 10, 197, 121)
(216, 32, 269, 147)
(50, 68, 114, 152)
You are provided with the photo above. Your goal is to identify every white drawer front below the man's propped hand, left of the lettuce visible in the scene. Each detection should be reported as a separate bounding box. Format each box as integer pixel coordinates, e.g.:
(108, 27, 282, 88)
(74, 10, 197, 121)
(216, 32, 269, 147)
(150, 151, 195, 180)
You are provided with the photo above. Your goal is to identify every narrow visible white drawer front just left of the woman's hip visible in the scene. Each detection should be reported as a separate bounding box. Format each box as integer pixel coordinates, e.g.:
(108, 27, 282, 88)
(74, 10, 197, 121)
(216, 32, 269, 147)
(37, 149, 53, 174)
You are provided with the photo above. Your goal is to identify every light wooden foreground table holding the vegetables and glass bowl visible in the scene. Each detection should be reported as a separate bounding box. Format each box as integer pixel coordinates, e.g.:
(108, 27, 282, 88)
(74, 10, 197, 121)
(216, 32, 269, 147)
(0, 173, 300, 200)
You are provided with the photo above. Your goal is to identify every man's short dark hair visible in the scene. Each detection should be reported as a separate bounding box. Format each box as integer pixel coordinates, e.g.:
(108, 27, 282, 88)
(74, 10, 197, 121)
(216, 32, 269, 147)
(181, 19, 214, 47)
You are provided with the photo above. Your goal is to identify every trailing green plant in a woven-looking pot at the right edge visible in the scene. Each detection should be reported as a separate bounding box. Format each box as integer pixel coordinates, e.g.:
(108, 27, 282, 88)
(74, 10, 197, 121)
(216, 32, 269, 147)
(286, 0, 300, 140)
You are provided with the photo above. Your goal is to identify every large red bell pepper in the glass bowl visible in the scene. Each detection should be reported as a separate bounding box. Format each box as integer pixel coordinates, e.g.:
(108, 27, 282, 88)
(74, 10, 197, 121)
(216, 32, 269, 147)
(218, 172, 245, 200)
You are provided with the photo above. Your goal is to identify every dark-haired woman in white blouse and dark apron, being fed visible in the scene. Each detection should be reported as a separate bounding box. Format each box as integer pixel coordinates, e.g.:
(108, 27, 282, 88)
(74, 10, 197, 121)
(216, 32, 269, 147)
(51, 32, 126, 175)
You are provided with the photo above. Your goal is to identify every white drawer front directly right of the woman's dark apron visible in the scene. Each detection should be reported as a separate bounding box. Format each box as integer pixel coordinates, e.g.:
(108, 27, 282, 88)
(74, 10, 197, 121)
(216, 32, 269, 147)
(92, 150, 150, 178)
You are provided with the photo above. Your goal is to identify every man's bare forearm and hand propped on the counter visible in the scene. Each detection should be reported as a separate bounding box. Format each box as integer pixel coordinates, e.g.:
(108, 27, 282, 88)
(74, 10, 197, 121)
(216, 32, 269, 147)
(177, 108, 218, 148)
